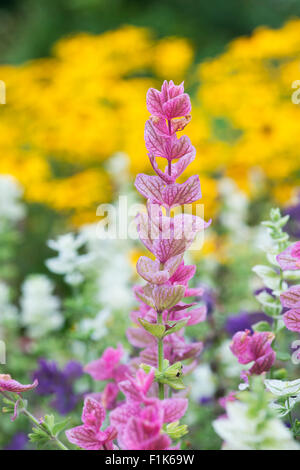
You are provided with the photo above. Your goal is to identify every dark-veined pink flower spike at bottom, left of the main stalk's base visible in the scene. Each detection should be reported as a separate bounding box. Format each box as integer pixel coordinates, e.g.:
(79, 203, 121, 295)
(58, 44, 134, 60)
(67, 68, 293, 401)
(66, 397, 117, 450)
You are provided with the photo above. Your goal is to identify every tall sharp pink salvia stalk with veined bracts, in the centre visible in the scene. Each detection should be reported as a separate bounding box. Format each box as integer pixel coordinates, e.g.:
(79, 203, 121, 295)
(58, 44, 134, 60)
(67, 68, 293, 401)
(135, 81, 208, 399)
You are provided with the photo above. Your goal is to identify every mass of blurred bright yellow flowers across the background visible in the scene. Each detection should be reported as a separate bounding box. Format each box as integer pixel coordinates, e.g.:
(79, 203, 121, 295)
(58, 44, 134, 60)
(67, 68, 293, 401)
(0, 20, 300, 224)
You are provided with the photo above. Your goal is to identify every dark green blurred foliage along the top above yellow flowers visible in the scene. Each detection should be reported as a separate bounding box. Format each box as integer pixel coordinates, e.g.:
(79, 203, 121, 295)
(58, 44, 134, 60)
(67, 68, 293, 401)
(0, 0, 300, 63)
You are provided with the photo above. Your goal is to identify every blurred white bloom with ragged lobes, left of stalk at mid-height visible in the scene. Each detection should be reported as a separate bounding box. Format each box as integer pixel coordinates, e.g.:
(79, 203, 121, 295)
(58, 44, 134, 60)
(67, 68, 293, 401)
(46, 233, 93, 286)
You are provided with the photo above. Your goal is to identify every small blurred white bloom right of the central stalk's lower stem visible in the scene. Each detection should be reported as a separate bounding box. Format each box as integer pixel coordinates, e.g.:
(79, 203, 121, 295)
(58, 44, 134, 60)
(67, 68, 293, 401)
(190, 364, 216, 401)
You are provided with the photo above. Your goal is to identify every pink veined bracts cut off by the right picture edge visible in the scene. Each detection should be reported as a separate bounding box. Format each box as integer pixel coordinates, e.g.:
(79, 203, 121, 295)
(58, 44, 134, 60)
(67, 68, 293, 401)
(277, 242, 300, 333)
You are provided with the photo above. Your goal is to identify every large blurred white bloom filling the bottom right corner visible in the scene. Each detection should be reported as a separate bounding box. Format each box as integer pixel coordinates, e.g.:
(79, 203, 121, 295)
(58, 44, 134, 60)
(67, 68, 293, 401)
(213, 401, 300, 450)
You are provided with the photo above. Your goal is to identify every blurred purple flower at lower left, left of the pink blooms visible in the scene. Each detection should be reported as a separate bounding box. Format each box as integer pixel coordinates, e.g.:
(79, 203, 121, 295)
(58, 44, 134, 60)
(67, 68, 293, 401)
(33, 359, 83, 415)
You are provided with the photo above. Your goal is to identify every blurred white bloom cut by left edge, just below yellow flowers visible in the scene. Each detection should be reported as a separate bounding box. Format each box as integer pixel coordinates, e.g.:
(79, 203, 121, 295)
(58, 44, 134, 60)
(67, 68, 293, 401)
(0, 175, 25, 223)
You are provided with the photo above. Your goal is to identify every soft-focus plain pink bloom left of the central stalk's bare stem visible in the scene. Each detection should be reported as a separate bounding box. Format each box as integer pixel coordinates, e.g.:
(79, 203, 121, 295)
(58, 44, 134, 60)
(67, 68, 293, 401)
(84, 344, 124, 380)
